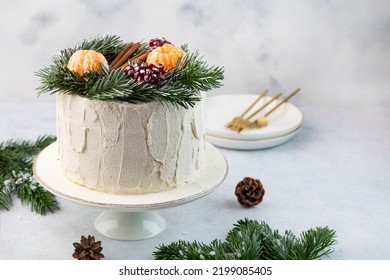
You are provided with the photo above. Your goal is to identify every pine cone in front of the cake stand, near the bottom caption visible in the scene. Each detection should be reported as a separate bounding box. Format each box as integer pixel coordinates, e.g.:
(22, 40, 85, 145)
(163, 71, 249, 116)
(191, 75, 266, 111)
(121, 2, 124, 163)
(72, 235, 104, 260)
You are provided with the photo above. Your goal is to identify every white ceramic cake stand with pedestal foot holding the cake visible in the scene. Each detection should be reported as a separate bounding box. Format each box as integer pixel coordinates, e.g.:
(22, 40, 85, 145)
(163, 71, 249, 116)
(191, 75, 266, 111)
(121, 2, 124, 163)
(33, 142, 228, 240)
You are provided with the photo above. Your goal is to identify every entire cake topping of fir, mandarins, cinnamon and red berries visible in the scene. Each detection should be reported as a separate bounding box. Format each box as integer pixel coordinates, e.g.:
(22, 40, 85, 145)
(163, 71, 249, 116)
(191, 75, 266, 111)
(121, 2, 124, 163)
(36, 35, 224, 108)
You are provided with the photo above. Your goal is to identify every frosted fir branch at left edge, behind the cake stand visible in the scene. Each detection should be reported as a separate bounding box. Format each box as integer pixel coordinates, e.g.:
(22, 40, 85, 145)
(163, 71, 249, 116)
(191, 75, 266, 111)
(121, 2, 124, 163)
(0, 136, 59, 215)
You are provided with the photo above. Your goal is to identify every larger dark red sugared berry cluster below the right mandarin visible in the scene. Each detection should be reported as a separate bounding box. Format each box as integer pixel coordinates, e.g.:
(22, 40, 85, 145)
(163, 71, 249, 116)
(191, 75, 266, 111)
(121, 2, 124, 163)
(125, 62, 165, 84)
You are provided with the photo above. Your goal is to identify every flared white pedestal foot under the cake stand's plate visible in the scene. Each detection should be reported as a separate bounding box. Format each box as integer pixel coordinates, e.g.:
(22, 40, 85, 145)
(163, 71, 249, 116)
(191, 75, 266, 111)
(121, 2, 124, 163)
(95, 210, 165, 241)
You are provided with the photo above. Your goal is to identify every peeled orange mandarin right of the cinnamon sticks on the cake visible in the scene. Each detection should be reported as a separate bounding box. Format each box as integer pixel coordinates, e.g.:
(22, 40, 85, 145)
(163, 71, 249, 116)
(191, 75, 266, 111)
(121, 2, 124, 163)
(146, 43, 186, 71)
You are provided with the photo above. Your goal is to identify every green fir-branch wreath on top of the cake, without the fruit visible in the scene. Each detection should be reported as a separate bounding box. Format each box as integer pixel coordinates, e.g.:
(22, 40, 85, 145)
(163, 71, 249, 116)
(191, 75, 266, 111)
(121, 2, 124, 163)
(36, 35, 224, 108)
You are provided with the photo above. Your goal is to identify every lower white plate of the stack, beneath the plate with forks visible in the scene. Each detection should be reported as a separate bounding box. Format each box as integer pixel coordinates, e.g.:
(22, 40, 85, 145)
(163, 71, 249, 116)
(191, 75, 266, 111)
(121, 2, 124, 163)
(206, 127, 301, 150)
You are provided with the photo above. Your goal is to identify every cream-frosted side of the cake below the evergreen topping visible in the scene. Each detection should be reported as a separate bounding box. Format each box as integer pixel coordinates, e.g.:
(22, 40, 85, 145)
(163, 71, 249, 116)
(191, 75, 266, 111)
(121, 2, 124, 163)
(57, 94, 205, 194)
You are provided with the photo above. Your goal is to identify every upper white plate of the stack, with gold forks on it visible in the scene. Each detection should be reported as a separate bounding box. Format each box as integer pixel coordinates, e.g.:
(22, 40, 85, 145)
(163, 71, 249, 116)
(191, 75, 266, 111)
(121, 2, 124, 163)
(206, 93, 303, 140)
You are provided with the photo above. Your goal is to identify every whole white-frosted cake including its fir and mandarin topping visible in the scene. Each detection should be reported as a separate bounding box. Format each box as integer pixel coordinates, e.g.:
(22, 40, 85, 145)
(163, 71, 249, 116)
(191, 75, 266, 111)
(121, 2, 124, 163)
(38, 35, 223, 195)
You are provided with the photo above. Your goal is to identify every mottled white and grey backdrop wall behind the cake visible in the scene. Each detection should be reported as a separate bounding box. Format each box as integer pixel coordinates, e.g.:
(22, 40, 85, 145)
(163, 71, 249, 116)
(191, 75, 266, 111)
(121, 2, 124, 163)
(0, 0, 390, 104)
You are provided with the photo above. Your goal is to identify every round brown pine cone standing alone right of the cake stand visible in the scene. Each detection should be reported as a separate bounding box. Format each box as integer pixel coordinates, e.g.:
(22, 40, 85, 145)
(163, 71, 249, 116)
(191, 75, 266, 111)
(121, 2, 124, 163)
(235, 177, 265, 207)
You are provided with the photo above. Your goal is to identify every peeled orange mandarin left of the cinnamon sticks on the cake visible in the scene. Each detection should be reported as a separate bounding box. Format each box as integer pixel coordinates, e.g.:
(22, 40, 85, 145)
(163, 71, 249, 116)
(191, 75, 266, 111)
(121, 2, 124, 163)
(67, 50, 108, 75)
